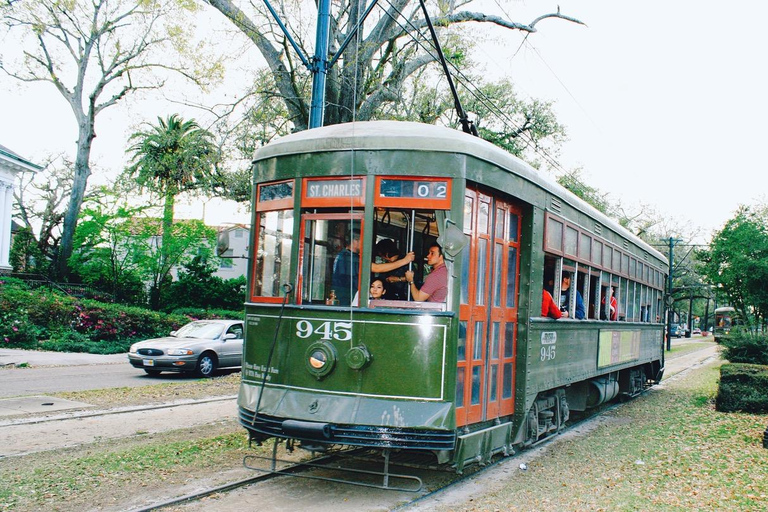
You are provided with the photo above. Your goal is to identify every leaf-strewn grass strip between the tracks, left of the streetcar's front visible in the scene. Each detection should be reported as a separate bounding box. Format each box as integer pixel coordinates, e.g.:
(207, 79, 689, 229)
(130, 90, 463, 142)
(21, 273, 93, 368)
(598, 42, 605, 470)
(0, 421, 265, 511)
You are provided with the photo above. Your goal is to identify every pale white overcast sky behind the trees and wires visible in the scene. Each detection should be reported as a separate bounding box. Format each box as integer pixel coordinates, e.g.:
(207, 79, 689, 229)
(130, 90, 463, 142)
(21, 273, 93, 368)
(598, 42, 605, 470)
(0, 0, 768, 242)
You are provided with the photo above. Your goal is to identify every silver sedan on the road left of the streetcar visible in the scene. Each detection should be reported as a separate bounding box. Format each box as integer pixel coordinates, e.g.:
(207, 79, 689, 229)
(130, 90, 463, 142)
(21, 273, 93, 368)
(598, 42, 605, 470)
(128, 320, 243, 377)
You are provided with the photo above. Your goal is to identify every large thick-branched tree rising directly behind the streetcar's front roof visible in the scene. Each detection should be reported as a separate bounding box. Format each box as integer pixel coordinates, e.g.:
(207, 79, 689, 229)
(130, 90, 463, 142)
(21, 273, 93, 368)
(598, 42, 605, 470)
(205, 0, 581, 137)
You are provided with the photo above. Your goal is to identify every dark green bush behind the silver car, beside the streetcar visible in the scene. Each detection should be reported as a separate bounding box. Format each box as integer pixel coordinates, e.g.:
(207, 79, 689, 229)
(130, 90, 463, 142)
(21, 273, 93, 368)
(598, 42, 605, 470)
(162, 256, 245, 316)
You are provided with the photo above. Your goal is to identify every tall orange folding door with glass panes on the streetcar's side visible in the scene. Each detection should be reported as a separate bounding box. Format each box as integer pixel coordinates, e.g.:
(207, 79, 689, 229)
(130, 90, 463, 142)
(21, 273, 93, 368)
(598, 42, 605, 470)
(456, 190, 521, 425)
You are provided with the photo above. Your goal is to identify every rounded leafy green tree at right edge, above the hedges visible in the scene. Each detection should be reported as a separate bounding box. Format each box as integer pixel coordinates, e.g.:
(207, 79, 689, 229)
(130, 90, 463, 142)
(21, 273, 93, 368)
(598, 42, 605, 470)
(698, 206, 768, 330)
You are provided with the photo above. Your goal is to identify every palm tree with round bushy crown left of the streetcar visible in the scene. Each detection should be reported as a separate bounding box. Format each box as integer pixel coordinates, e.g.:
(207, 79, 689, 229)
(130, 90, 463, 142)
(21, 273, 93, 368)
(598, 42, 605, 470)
(126, 114, 219, 307)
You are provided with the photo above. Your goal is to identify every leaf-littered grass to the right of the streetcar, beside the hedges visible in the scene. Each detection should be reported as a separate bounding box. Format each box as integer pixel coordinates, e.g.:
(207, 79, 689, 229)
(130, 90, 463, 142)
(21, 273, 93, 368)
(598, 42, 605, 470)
(450, 365, 768, 511)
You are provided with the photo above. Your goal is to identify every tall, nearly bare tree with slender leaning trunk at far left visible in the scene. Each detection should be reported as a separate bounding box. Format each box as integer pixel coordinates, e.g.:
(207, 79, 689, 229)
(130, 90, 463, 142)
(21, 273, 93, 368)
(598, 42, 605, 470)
(0, 0, 222, 277)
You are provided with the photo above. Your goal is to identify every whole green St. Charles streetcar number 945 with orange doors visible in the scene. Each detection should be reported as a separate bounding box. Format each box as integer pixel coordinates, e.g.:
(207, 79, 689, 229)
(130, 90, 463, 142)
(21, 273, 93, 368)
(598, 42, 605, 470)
(238, 121, 666, 472)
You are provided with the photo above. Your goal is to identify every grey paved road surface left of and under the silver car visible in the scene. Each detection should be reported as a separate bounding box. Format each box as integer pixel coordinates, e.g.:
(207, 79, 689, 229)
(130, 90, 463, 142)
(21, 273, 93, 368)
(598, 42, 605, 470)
(0, 349, 206, 398)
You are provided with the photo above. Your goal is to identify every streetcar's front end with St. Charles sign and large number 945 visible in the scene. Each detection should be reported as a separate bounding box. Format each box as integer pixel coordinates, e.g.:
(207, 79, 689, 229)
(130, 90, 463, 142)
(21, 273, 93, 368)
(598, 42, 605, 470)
(238, 134, 462, 454)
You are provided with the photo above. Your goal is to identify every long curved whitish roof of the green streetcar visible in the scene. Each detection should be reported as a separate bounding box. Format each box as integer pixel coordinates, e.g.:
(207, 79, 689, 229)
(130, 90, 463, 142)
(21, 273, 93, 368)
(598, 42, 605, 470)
(253, 121, 665, 261)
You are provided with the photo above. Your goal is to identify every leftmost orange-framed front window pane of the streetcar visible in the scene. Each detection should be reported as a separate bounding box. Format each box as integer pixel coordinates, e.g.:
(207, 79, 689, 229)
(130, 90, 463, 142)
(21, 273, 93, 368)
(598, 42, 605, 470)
(252, 210, 293, 297)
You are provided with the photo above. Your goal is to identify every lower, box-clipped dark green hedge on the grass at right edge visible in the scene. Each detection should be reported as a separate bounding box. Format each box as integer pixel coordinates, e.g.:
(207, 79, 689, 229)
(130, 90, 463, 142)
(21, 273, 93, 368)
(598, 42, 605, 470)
(715, 363, 768, 414)
